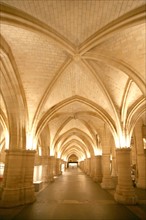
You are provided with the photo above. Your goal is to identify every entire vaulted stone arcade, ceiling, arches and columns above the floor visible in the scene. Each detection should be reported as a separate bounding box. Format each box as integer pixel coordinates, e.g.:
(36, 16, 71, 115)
(0, 0, 146, 207)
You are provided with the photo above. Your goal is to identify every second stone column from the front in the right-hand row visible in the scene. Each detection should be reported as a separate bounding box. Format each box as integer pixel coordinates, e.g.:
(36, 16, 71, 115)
(101, 154, 115, 189)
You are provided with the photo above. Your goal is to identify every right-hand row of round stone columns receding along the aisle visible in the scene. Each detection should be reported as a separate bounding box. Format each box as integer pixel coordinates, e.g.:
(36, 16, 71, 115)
(80, 148, 146, 204)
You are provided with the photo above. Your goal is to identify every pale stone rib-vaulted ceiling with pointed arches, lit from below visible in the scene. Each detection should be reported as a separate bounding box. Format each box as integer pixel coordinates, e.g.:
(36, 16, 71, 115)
(0, 0, 146, 162)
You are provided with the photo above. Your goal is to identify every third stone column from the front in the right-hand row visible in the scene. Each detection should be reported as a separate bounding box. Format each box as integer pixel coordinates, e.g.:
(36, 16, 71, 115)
(93, 155, 102, 182)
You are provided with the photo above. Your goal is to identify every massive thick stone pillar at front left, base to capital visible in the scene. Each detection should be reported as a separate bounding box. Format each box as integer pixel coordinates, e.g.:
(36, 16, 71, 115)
(0, 149, 35, 207)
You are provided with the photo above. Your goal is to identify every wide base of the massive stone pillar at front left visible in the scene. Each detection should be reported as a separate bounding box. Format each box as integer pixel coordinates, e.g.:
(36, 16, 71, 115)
(0, 186, 36, 208)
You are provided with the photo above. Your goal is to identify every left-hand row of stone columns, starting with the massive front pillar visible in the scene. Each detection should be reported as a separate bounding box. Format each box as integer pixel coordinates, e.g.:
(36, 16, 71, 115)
(0, 152, 67, 208)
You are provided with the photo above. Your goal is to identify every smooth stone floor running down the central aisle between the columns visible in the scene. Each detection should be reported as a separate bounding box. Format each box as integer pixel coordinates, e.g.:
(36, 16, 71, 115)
(0, 168, 146, 220)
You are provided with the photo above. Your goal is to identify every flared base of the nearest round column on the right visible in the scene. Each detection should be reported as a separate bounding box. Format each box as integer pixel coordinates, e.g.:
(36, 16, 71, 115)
(114, 187, 138, 205)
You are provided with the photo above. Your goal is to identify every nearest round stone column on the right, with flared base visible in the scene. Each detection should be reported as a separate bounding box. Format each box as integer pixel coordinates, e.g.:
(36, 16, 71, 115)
(114, 148, 137, 205)
